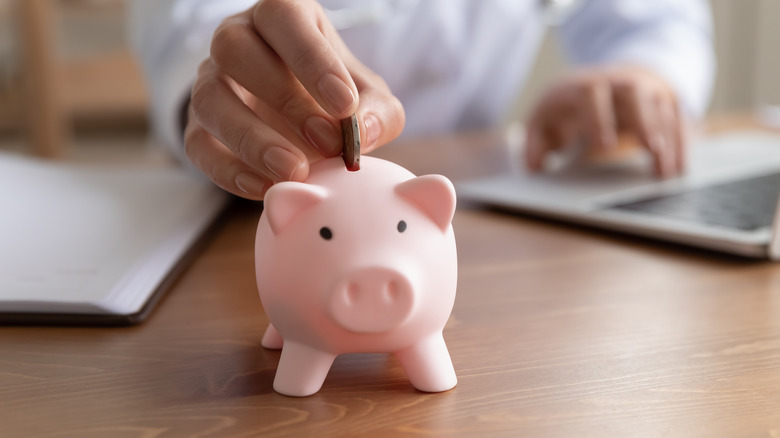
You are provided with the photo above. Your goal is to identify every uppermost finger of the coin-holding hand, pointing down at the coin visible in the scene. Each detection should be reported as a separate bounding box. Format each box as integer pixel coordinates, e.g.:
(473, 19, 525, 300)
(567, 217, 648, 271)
(252, 0, 358, 119)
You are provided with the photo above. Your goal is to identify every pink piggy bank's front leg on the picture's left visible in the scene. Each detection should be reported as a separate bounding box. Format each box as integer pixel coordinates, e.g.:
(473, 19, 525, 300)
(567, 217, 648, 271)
(274, 340, 336, 397)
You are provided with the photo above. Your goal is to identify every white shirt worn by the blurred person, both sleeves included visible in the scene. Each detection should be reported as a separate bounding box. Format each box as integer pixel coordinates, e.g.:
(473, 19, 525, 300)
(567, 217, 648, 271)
(129, 0, 714, 161)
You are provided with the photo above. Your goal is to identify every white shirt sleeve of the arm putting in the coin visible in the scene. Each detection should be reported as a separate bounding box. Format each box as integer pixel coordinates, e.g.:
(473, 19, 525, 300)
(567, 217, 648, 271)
(128, 0, 255, 162)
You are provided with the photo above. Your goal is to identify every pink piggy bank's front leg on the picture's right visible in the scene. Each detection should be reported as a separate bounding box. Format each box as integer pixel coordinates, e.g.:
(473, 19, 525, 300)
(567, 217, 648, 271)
(395, 333, 458, 392)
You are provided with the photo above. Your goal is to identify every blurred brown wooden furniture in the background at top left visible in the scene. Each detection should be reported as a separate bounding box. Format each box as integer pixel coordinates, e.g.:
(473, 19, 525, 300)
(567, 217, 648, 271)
(9, 0, 148, 158)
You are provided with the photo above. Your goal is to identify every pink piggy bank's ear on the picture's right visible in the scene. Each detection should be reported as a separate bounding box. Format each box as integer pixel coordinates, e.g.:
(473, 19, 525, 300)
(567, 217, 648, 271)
(395, 175, 455, 231)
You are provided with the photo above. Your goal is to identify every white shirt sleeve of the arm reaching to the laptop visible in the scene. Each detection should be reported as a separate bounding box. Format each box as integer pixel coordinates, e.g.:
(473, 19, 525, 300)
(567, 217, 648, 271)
(559, 0, 715, 119)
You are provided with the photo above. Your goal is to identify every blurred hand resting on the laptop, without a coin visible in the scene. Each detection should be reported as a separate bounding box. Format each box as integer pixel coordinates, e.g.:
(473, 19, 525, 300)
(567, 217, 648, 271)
(525, 66, 685, 178)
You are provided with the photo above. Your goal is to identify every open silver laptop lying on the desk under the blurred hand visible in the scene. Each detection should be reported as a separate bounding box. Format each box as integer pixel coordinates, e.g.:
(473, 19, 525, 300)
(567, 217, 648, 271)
(457, 131, 780, 259)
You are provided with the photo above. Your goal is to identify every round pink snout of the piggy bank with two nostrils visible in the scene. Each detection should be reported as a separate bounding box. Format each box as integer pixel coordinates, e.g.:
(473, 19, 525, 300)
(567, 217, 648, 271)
(330, 267, 415, 333)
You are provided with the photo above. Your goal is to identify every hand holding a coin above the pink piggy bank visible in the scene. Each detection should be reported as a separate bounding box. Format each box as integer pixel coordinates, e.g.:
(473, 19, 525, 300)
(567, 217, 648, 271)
(184, 0, 405, 199)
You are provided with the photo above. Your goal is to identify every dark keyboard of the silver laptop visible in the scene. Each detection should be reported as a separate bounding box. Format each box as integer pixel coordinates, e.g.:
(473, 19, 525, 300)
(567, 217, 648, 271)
(610, 173, 780, 231)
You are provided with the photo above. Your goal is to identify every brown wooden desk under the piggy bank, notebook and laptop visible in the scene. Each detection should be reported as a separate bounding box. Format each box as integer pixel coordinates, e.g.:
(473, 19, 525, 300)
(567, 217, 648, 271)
(0, 128, 780, 438)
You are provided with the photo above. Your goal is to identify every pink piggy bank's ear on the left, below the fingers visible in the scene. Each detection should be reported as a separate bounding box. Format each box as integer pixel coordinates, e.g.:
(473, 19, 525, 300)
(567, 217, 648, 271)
(263, 181, 328, 234)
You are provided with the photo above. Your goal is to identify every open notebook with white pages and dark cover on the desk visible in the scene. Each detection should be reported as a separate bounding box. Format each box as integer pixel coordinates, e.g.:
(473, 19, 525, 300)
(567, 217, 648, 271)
(0, 153, 229, 324)
